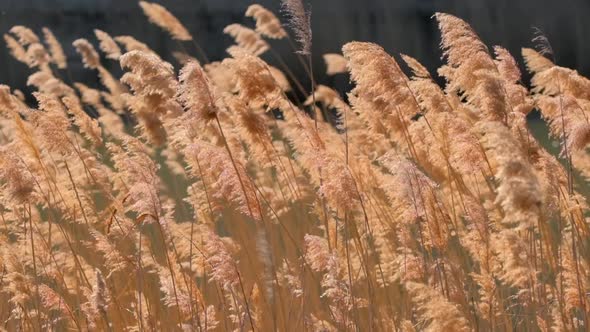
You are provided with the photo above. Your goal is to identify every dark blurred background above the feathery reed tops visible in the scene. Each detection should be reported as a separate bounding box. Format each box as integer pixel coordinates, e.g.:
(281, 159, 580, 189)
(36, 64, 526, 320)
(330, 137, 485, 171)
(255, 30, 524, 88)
(0, 0, 590, 91)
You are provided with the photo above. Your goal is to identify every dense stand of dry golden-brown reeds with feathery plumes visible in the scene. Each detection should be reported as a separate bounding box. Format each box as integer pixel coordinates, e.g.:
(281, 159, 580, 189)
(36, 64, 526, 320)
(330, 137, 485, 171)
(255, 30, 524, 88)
(0, 0, 590, 331)
